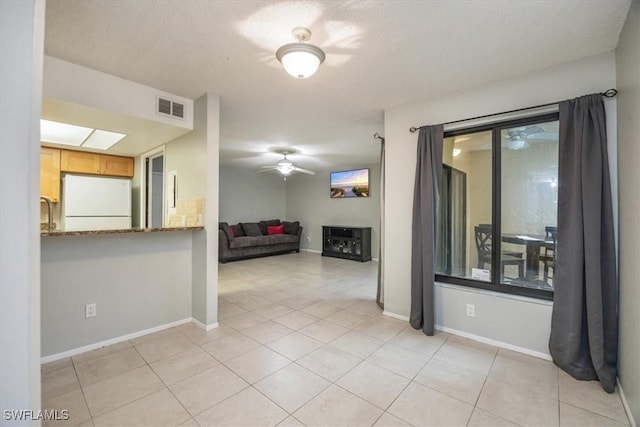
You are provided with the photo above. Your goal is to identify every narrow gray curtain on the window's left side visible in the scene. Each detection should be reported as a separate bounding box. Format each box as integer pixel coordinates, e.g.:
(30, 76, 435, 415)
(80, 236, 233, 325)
(409, 125, 443, 335)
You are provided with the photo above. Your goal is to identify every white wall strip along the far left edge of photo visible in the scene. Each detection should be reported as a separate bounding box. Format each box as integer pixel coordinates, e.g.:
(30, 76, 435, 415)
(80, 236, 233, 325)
(0, 0, 45, 416)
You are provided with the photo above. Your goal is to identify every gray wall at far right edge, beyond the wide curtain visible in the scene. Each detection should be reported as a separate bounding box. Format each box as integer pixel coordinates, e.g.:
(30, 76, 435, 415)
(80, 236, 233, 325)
(616, 0, 640, 423)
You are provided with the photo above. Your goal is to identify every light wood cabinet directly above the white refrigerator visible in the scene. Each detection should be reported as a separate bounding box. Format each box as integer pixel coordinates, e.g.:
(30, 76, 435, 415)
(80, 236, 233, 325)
(60, 150, 133, 178)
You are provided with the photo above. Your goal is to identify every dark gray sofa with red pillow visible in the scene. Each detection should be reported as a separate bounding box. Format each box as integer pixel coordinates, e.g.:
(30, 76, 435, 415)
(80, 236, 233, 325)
(218, 219, 302, 263)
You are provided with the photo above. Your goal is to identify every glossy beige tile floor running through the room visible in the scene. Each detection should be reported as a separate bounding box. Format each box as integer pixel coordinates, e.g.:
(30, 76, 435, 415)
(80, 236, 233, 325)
(42, 253, 629, 427)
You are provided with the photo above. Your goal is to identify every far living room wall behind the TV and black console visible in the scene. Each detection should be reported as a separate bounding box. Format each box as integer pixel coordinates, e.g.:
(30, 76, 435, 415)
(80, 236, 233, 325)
(286, 164, 380, 258)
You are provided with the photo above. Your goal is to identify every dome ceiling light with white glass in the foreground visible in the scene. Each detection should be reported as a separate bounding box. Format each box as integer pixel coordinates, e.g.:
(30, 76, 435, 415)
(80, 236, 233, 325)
(276, 27, 324, 79)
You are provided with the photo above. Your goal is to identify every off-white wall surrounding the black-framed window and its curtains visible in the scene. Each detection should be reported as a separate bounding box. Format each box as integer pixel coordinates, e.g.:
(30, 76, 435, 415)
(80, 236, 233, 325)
(384, 52, 617, 354)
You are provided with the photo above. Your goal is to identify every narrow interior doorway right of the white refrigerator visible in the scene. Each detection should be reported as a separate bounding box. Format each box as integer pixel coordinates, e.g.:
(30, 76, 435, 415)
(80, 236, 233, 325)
(144, 151, 165, 228)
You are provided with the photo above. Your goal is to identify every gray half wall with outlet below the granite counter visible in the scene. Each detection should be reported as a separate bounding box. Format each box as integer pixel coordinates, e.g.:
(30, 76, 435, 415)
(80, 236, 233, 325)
(41, 231, 194, 356)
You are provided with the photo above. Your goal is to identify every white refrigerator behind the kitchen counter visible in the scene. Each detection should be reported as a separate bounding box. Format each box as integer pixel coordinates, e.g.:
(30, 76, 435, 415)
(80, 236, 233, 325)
(61, 174, 131, 231)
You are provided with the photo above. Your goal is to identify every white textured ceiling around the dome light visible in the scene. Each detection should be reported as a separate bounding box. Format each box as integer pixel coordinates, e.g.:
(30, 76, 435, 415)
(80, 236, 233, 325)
(45, 0, 630, 169)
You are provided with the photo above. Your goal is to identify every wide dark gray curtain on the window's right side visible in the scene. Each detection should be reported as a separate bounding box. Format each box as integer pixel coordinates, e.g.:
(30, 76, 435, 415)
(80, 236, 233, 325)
(549, 94, 618, 393)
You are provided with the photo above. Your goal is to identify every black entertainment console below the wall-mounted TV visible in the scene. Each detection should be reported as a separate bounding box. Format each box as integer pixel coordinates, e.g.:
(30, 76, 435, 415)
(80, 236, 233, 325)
(322, 225, 371, 262)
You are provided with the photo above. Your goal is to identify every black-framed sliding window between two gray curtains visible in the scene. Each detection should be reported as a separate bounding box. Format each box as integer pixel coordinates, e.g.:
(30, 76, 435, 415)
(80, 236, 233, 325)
(436, 113, 558, 299)
